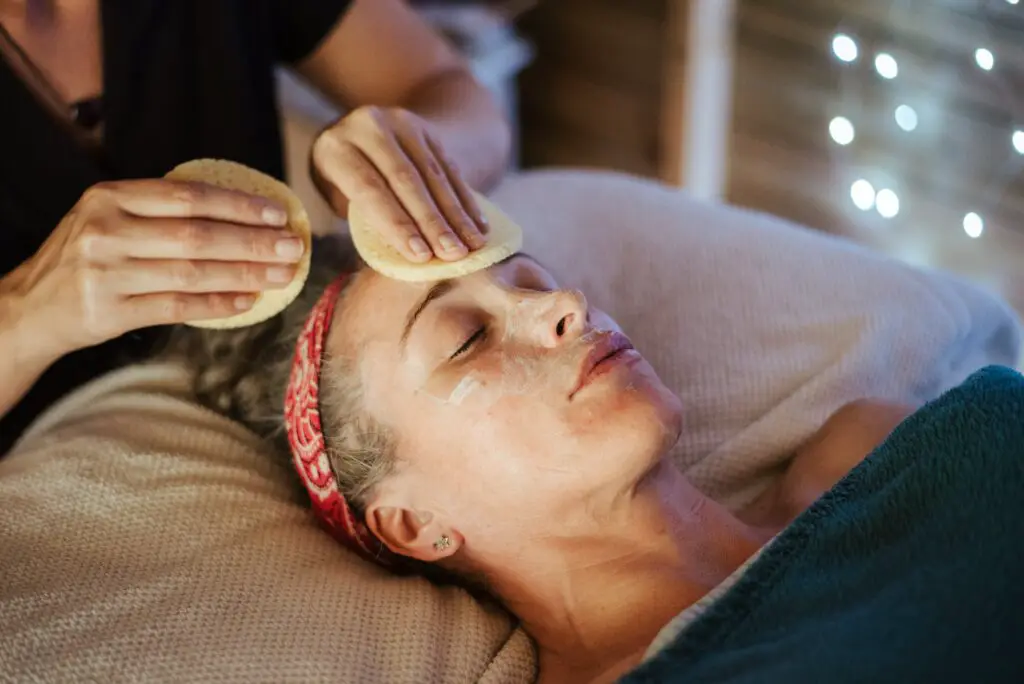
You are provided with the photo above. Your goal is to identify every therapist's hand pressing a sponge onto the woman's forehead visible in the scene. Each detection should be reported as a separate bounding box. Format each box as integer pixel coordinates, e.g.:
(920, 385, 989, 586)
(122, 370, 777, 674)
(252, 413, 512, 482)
(310, 106, 487, 262)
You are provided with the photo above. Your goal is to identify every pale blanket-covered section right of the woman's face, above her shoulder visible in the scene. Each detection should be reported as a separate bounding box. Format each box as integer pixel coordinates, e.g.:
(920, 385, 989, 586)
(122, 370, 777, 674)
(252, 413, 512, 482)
(494, 171, 1020, 506)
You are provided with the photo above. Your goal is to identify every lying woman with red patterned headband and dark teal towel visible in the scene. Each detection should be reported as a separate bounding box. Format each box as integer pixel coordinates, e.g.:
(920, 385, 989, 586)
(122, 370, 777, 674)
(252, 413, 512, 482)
(163, 236, 1024, 684)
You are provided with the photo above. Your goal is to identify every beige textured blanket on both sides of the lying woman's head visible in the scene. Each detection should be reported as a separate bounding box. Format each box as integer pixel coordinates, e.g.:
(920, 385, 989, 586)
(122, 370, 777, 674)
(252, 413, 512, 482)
(0, 167, 1019, 683)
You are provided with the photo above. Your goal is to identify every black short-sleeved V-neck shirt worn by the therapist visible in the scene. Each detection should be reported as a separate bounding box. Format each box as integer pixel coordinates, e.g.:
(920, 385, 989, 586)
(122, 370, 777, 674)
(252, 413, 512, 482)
(0, 0, 349, 455)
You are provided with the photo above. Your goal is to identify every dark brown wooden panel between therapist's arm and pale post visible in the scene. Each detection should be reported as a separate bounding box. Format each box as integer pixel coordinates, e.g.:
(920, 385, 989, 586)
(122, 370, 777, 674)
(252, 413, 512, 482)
(518, 0, 666, 176)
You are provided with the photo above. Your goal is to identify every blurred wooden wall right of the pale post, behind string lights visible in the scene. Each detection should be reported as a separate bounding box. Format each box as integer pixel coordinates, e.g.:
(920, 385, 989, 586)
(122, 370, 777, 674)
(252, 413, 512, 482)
(727, 0, 1024, 310)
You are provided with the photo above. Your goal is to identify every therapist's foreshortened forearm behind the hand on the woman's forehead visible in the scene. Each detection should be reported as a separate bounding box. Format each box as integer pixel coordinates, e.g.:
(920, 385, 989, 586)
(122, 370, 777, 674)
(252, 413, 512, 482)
(401, 69, 511, 191)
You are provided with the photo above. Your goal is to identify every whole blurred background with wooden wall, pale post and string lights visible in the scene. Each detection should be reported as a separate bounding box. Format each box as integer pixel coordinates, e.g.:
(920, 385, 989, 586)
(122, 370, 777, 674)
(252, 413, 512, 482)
(288, 0, 1024, 312)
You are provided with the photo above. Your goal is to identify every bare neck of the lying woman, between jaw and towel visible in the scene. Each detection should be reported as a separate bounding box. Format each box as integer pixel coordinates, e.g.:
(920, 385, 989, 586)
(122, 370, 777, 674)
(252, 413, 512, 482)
(490, 461, 767, 682)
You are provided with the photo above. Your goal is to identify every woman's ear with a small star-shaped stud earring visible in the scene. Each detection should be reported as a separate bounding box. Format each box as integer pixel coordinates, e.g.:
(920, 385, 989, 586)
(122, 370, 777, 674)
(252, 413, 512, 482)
(367, 505, 464, 563)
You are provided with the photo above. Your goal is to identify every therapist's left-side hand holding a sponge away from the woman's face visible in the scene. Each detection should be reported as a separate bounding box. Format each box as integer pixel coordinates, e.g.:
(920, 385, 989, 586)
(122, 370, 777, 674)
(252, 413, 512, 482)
(3, 179, 303, 356)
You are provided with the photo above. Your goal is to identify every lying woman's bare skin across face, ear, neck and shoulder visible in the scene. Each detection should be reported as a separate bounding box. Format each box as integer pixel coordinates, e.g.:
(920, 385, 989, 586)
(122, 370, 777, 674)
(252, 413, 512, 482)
(319, 254, 908, 683)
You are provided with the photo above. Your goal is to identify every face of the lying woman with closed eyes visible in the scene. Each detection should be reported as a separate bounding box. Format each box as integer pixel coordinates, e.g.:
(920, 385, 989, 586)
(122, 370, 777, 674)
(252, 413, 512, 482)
(330, 254, 680, 557)
